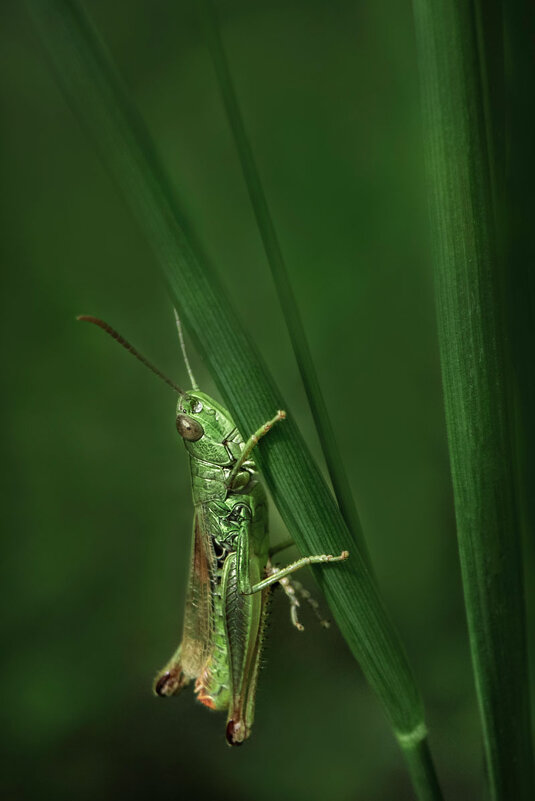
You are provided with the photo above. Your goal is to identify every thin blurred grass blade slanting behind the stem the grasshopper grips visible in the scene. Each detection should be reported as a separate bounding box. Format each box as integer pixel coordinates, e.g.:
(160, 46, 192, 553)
(200, 0, 371, 567)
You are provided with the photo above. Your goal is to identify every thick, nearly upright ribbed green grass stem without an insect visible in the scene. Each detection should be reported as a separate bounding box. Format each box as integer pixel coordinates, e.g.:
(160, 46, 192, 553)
(414, 0, 535, 801)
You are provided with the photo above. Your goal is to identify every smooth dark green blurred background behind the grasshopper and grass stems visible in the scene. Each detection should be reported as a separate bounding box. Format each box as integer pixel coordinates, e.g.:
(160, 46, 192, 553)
(0, 0, 528, 801)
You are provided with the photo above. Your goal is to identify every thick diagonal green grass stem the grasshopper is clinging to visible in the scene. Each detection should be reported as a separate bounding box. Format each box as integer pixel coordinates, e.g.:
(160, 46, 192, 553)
(28, 0, 440, 799)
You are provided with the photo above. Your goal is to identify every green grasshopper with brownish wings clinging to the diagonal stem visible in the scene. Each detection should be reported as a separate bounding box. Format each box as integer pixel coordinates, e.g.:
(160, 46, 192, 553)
(78, 312, 349, 745)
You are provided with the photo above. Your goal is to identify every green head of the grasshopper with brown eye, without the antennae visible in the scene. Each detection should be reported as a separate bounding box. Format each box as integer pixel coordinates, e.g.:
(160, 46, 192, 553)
(176, 390, 236, 455)
